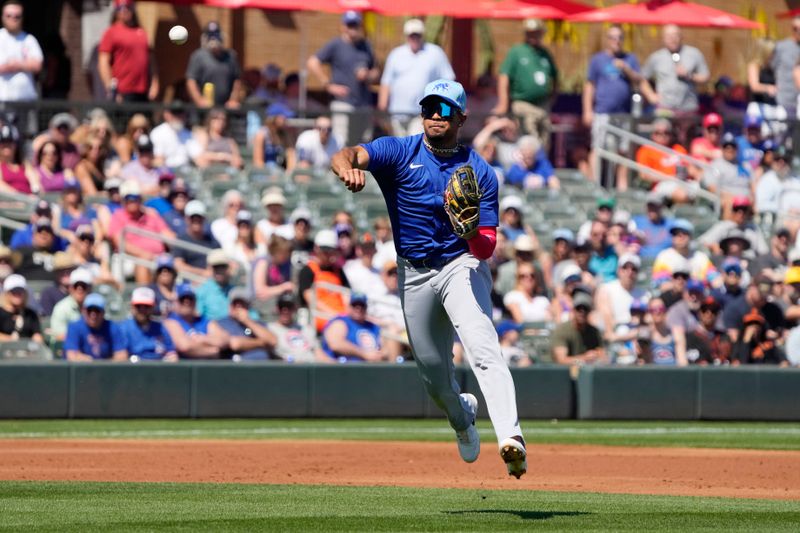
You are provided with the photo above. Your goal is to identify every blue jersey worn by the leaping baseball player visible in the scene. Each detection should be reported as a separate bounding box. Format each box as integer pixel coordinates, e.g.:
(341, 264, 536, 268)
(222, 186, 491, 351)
(362, 134, 499, 261)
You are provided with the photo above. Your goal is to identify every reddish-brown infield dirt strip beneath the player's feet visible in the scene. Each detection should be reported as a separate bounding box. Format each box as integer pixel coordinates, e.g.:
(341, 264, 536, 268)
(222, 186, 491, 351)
(0, 439, 800, 500)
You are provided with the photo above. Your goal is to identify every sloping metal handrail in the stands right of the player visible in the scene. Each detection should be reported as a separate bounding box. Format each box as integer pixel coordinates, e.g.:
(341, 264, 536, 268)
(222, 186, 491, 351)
(595, 124, 721, 215)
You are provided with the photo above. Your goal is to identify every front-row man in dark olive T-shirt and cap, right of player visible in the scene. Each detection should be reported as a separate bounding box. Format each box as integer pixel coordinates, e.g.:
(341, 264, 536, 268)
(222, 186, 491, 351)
(551, 290, 606, 365)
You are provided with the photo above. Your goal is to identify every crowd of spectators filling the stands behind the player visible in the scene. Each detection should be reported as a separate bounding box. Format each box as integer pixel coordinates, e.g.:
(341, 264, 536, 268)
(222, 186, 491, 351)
(0, 0, 800, 366)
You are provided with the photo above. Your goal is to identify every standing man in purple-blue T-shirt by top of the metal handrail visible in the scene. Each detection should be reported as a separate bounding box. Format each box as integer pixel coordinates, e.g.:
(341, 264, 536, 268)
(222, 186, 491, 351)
(583, 24, 642, 187)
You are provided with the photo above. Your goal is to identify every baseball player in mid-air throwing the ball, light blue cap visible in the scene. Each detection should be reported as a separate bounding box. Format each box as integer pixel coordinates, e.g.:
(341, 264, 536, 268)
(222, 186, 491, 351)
(331, 80, 527, 478)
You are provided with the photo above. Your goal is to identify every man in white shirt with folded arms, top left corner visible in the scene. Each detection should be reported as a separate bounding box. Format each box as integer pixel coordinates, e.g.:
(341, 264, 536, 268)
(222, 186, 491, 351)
(0, 1, 44, 102)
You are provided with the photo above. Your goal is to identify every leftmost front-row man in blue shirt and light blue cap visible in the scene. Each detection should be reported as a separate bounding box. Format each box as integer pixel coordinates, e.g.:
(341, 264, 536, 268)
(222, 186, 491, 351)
(64, 293, 128, 361)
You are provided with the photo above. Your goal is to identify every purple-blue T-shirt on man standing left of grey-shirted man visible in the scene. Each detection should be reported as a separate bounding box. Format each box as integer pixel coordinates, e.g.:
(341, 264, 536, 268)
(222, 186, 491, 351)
(587, 51, 639, 113)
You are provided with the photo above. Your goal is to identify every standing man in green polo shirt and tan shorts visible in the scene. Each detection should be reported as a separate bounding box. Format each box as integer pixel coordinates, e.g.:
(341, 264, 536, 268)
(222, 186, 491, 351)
(494, 19, 558, 147)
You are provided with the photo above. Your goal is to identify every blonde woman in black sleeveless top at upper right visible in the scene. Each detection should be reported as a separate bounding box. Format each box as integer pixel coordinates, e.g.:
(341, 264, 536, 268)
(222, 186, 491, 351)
(747, 39, 787, 135)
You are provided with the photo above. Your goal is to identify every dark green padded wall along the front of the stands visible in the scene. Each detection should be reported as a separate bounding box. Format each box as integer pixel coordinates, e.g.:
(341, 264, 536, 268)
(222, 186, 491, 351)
(0, 362, 800, 420)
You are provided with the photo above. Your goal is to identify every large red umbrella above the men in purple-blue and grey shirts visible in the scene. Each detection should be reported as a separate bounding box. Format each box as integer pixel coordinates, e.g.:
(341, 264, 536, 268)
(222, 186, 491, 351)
(568, 0, 761, 30)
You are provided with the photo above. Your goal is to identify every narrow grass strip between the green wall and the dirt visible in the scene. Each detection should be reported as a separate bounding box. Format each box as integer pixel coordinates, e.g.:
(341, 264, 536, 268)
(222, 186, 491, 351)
(0, 418, 800, 450)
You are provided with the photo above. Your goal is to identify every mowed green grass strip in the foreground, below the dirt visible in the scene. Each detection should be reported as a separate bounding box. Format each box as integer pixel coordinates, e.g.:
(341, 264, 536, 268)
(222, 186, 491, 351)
(0, 482, 800, 532)
